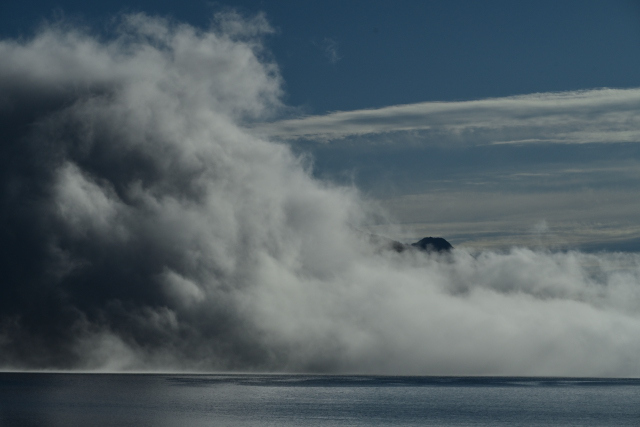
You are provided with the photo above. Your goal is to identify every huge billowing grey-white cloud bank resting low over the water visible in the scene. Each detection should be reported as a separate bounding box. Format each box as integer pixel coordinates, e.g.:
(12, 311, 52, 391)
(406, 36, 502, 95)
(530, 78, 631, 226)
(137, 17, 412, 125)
(0, 15, 640, 376)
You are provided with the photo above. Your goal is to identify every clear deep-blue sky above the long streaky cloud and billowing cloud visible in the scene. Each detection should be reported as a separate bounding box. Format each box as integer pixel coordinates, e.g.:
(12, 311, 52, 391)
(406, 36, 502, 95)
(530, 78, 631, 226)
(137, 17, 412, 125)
(5, 0, 640, 113)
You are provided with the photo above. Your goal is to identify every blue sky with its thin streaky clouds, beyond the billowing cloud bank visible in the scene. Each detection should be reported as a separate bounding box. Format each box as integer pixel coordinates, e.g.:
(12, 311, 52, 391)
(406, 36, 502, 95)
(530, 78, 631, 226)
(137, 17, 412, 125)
(5, 1, 640, 250)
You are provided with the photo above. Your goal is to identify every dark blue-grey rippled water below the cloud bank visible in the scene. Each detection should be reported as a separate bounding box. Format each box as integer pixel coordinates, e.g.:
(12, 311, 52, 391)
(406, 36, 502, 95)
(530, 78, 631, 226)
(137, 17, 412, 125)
(0, 373, 640, 426)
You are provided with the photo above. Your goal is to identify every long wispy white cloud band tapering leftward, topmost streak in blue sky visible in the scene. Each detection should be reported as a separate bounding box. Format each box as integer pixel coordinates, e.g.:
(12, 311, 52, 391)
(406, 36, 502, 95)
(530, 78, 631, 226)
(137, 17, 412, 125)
(256, 88, 640, 145)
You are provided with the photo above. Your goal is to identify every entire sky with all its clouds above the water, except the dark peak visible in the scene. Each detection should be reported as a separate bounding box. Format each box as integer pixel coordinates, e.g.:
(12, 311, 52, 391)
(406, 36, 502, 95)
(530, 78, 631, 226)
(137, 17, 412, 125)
(0, 1, 640, 377)
